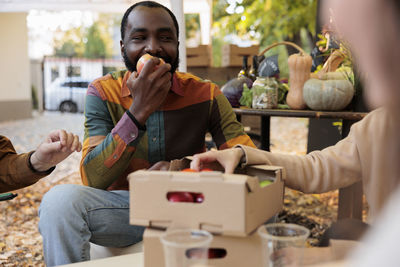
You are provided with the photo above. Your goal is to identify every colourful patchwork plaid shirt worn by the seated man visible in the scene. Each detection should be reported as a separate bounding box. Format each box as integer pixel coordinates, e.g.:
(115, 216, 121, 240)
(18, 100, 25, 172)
(80, 70, 254, 190)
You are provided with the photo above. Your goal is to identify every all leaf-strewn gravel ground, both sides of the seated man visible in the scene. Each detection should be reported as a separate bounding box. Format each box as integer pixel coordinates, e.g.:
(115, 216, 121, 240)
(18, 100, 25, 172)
(0, 112, 337, 267)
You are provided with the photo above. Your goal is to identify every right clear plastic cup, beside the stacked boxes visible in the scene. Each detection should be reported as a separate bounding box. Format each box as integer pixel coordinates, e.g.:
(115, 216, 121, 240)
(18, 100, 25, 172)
(257, 223, 310, 267)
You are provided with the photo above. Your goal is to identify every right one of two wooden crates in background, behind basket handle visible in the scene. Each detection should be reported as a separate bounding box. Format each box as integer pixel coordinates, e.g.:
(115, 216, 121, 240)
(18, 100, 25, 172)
(221, 44, 260, 67)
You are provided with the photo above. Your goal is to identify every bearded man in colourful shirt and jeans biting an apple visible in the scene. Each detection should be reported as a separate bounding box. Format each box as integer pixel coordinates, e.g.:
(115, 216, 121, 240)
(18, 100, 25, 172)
(39, 1, 254, 266)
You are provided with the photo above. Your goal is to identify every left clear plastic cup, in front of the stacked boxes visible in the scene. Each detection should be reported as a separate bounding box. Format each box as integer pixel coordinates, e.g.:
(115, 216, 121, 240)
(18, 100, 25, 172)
(161, 229, 212, 267)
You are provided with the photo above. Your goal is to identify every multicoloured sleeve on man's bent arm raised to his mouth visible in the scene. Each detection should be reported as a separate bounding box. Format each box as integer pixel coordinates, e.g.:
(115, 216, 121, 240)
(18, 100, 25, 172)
(80, 85, 144, 189)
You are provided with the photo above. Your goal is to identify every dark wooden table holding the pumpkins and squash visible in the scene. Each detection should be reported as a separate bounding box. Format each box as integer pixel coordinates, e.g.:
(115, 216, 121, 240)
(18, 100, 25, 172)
(233, 108, 368, 220)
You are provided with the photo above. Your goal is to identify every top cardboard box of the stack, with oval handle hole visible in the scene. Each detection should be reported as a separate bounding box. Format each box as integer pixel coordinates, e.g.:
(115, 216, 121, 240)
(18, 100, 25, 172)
(128, 159, 284, 236)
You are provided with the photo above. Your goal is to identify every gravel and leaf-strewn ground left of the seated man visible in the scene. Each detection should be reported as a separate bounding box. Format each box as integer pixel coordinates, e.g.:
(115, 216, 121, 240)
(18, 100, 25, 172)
(0, 112, 84, 267)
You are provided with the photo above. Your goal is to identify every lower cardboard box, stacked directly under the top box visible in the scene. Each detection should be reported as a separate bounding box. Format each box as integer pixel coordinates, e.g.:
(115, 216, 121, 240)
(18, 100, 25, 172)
(143, 228, 262, 267)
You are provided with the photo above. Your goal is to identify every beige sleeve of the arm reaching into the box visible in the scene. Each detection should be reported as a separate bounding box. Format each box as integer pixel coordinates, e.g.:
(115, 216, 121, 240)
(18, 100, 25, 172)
(240, 124, 361, 193)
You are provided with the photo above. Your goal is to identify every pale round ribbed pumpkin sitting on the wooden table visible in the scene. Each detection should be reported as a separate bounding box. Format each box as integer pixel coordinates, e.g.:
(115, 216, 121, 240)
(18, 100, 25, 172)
(303, 75, 354, 111)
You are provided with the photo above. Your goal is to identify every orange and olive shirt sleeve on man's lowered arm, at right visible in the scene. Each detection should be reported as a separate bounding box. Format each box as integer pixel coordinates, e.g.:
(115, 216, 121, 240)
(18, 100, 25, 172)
(209, 84, 255, 149)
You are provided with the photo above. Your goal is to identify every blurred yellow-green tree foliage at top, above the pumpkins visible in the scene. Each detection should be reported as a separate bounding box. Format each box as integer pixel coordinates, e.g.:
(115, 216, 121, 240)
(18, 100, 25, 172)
(214, 0, 317, 46)
